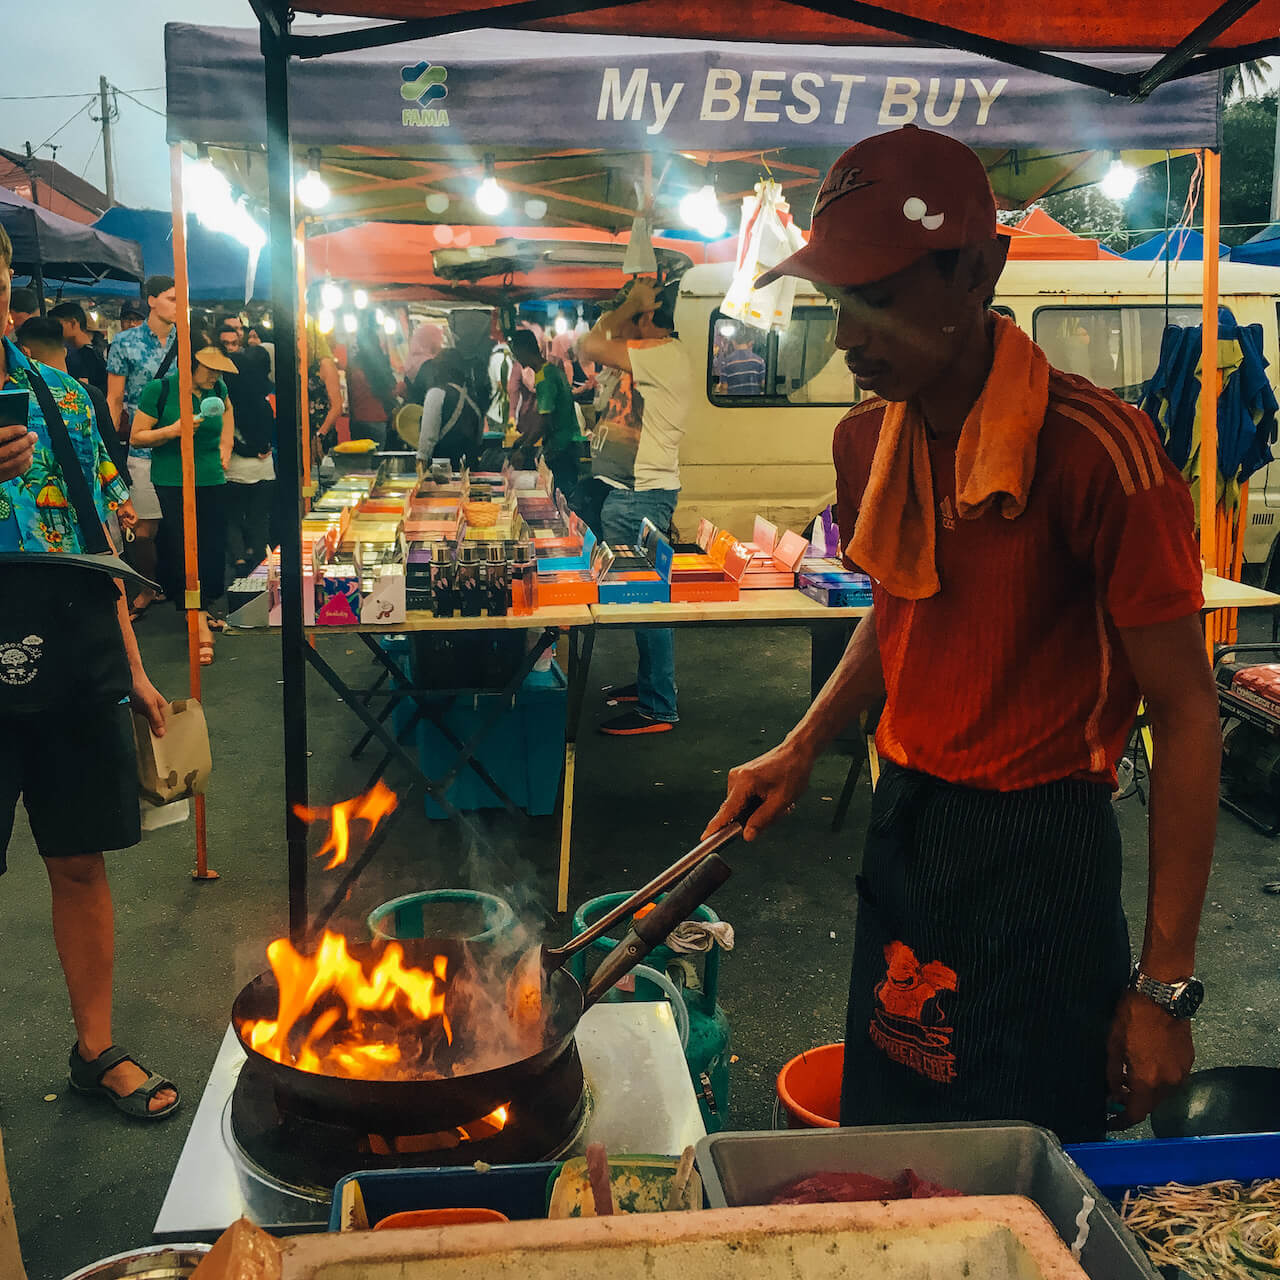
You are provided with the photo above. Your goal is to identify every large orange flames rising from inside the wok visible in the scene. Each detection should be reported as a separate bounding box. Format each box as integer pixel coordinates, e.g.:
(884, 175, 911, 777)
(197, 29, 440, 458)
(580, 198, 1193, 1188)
(241, 929, 455, 1080)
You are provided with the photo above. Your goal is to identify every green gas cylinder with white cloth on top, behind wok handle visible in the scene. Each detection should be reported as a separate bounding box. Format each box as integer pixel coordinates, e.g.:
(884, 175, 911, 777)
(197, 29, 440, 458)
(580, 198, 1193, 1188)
(570, 893, 730, 1133)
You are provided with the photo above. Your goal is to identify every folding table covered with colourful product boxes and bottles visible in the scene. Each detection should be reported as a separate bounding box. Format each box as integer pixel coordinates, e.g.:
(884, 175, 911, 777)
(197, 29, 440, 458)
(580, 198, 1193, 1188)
(228, 453, 870, 910)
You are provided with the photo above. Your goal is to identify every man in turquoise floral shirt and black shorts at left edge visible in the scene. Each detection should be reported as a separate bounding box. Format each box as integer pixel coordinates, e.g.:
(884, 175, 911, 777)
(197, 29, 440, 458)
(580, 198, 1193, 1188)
(0, 228, 179, 1120)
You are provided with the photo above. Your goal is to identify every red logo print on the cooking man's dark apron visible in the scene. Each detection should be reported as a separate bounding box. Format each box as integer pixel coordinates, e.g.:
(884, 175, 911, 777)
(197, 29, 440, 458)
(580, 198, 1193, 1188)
(868, 942, 957, 1084)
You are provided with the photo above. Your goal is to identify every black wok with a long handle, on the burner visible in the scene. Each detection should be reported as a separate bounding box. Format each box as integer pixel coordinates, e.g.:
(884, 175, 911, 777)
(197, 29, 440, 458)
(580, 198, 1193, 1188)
(232, 854, 731, 1133)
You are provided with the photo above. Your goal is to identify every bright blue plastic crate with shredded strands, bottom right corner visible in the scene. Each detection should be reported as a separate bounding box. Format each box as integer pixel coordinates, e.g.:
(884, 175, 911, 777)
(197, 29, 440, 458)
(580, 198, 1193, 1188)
(1066, 1133, 1280, 1199)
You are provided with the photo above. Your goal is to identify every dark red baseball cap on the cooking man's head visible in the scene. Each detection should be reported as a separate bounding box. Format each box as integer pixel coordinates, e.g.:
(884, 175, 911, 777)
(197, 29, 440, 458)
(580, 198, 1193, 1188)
(755, 124, 996, 289)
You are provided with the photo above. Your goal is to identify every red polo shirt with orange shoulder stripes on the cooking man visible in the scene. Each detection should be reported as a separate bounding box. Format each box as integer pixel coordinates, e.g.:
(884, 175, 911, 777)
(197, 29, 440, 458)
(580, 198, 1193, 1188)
(835, 370, 1203, 791)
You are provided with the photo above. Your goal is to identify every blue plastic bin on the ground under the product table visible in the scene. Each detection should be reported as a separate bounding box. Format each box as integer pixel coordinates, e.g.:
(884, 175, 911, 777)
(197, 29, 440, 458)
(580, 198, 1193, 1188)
(417, 663, 568, 818)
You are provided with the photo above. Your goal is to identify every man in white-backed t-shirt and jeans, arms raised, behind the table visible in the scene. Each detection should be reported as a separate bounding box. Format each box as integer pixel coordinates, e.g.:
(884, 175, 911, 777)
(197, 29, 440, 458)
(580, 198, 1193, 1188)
(577, 280, 692, 736)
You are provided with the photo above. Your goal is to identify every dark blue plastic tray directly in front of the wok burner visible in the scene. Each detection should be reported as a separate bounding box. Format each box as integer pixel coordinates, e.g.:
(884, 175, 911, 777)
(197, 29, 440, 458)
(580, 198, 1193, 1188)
(329, 1161, 559, 1231)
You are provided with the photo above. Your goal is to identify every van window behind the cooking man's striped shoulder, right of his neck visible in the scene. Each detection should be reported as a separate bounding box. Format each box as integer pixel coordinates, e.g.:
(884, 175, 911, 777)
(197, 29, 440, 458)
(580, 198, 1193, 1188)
(1034, 306, 1201, 404)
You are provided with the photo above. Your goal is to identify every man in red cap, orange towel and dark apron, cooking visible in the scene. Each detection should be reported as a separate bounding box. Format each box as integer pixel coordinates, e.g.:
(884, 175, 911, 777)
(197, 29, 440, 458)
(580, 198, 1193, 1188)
(708, 127, 1221, 1142)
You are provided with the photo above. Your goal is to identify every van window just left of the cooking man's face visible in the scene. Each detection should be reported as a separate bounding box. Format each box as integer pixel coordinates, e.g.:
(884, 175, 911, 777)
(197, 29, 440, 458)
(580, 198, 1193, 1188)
(707, 306, 855, 408)
